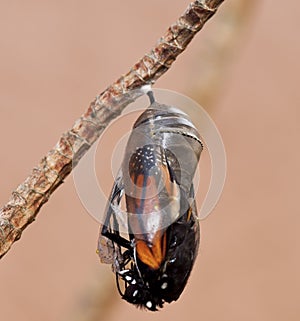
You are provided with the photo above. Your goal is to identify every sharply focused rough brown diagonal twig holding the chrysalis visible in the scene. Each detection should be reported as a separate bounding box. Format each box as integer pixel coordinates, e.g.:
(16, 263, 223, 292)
(0, 0, 224, 257)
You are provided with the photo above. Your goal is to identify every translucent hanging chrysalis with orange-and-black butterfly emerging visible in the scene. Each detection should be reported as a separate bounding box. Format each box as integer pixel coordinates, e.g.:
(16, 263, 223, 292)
(97, 92, 203, 311)
